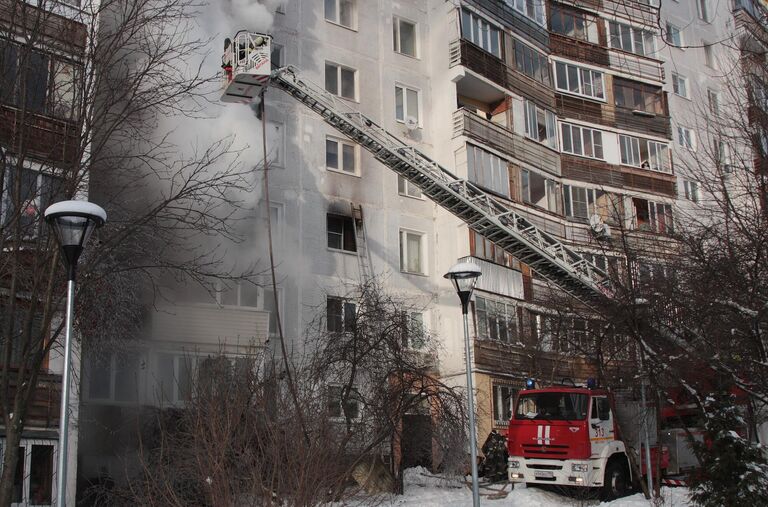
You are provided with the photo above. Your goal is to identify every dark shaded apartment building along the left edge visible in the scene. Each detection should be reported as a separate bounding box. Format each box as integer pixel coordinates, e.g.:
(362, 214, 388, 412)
(0, 1, 88, 505)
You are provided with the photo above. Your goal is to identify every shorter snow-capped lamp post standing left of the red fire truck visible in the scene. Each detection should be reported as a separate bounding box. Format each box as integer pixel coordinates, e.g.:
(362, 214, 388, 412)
(445, 262, 482, 507)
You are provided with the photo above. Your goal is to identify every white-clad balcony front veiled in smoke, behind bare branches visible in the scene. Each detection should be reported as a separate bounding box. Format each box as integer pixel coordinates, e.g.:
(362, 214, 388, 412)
(151, 304, 270, 346)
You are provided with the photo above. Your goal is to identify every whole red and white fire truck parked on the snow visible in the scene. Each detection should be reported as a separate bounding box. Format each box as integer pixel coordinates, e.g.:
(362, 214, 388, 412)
(507, 386, 680, 498)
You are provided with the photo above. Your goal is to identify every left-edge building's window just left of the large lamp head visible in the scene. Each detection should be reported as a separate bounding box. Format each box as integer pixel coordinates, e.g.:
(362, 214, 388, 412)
(0, 167, 63, 239)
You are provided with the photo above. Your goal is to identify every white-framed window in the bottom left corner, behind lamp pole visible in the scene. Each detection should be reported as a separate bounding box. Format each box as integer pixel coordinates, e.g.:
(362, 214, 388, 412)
(0, 439, 58, 506)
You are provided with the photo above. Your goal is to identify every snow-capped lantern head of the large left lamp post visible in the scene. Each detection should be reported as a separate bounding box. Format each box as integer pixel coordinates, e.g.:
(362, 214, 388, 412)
(45, 201, 107, 280)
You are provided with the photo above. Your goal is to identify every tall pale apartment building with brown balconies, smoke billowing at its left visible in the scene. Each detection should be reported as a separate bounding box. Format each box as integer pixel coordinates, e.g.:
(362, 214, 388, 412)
(72, 0, 758, 492)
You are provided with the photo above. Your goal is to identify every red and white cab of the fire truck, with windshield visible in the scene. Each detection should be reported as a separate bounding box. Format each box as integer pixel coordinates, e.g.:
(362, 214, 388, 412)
(507, 387, 630, 497)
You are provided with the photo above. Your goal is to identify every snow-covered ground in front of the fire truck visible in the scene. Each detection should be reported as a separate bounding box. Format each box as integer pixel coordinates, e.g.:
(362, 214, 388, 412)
(343, 467, 691, 507)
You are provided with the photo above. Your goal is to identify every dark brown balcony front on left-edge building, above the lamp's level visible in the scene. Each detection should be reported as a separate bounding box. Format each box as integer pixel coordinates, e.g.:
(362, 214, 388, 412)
(0, 105, 80, 164)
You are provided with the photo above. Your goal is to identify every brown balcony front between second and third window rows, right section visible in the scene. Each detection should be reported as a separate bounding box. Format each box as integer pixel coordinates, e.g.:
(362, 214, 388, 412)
(555, 93, 672, 138)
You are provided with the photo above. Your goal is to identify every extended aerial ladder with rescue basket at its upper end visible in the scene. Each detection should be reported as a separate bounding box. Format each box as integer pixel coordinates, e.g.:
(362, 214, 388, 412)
(221, 31, 611, 305)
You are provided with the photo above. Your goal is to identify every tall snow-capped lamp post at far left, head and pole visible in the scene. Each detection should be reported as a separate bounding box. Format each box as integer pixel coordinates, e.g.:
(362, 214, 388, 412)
(45, 201, 107, 507)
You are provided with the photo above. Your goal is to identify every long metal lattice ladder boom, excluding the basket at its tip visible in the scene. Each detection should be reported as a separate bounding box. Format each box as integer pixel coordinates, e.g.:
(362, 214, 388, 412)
(269, 67, 610, 301)
